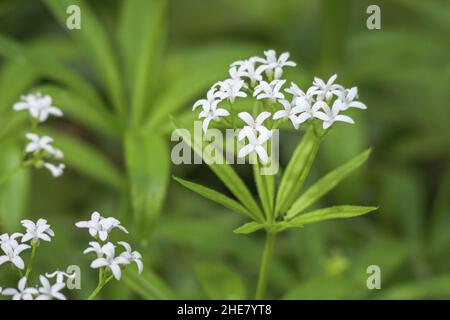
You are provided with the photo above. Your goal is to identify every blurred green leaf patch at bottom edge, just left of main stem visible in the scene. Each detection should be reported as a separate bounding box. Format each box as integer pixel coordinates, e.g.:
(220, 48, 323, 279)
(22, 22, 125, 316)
(195, 263, 247, 300)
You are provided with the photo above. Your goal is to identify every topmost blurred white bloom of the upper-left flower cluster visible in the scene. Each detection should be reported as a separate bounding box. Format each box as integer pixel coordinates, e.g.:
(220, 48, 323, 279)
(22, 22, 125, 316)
(13, 93, 63, 122)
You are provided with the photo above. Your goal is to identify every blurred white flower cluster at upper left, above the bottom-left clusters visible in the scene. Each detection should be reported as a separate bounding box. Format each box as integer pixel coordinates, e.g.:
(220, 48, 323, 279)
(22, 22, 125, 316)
(13, 93, 65, 178)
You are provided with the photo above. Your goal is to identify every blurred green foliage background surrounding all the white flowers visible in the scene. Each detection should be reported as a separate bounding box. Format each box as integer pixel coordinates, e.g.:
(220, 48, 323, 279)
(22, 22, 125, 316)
(0, 0, 450, 299)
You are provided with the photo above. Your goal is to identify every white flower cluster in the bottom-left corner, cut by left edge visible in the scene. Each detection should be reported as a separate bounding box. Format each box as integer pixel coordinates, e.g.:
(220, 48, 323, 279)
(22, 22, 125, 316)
(0, 219, 66, 300)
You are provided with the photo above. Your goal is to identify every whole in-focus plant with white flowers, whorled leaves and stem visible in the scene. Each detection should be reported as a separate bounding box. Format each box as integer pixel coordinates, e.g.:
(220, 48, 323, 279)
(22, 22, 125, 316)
(174, 50, 377, 298)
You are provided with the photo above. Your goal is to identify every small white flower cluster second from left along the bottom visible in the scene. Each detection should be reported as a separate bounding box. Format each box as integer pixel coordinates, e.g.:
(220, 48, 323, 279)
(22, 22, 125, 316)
(75, 212, 144, 281)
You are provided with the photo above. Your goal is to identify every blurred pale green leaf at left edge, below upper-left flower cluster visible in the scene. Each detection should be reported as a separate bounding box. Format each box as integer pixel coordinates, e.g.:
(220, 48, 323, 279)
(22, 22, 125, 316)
(0, 141, 30, 233)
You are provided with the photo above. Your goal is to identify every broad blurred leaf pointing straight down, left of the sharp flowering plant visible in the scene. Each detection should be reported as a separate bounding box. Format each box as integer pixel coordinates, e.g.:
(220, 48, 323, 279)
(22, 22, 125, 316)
(125, 131, 170, 237)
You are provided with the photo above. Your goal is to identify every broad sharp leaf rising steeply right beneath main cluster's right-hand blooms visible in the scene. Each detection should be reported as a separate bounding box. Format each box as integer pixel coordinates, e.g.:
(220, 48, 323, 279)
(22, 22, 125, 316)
(275, 126, 322, 214)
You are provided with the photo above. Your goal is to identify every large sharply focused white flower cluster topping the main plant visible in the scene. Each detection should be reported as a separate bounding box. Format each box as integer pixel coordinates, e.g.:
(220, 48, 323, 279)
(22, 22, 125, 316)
(193, 50, 366, 163)
